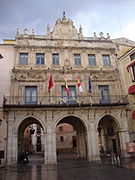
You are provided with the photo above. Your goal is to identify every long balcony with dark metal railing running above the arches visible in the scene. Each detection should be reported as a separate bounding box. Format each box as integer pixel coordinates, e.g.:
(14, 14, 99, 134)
(3, 95, 128, 108)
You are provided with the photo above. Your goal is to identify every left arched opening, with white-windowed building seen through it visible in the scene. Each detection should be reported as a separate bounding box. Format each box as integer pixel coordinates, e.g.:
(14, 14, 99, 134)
(18, 117, 45, 163)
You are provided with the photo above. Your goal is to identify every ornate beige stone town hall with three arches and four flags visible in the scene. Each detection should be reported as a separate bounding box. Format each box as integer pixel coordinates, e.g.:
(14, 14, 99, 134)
(0, 13, 130, 165)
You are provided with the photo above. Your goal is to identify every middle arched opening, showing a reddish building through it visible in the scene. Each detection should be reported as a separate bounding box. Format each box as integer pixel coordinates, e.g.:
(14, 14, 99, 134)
(56, 116, 88, 158)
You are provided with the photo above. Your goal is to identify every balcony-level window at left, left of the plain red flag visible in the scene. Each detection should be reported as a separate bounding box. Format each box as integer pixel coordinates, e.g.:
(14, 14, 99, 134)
(25, 86, 37, 104)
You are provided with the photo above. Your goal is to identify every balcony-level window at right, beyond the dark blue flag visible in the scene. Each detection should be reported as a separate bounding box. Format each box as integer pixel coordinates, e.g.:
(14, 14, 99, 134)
(98, 85, 110, 104)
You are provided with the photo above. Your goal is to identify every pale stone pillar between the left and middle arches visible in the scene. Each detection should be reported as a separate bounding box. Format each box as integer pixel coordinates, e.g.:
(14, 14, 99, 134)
(44, 124, 57, 165)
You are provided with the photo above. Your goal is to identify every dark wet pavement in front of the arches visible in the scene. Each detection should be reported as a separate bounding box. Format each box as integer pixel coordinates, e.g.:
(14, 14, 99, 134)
(0, 155, 135, 180)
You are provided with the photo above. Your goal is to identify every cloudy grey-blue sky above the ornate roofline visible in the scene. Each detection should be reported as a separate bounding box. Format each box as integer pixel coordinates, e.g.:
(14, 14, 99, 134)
(0, 0, 135, 43)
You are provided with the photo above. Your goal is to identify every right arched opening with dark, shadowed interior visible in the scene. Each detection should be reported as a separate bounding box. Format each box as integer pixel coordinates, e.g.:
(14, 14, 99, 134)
(97, 115, 121, 154)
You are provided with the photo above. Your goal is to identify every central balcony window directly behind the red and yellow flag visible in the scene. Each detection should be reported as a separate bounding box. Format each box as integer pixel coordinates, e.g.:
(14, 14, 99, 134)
(61, 86, 76, 104)
